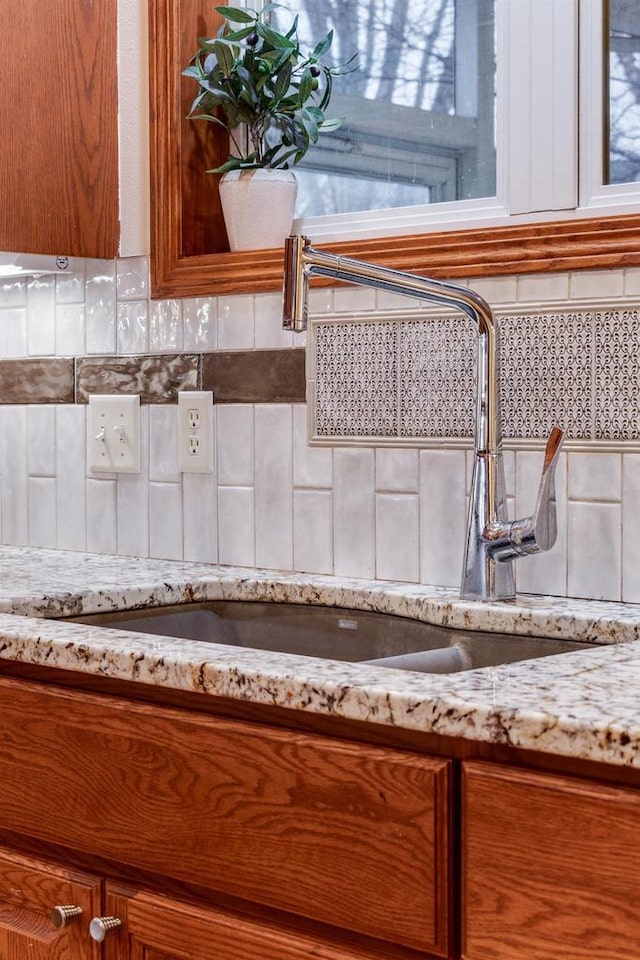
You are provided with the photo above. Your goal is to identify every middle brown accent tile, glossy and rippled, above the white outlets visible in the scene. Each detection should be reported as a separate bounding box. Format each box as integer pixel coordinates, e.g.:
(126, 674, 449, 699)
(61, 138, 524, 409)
(76, 353, 200, 403)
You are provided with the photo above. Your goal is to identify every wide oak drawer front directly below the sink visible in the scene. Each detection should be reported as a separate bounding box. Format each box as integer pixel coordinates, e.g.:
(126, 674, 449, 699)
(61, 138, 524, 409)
(0, 680, 449, 954)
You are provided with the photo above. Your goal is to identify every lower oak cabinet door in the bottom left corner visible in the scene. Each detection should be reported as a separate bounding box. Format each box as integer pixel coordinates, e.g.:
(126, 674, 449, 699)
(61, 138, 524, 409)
(0, 847, 101, 960)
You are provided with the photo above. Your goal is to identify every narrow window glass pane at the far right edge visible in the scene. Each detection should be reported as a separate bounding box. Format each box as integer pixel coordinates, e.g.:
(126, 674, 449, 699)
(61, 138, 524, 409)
(605, 0, 640, 183)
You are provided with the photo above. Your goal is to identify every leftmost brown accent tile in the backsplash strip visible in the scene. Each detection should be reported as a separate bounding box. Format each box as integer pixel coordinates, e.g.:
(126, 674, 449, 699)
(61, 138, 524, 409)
(0, 357, 73, 404)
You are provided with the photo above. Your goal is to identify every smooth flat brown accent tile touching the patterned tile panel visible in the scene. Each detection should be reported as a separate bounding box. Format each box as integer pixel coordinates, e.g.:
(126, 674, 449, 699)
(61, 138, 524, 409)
(202, 349, 306, 403)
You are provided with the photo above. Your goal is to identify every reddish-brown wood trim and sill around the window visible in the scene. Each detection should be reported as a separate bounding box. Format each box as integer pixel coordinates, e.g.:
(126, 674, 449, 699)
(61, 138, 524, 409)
(149, 0, 640, 297)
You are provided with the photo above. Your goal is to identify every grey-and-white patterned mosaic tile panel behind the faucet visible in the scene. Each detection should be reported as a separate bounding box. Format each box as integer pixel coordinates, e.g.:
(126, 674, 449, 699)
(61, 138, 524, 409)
(307, 306, 640, 446)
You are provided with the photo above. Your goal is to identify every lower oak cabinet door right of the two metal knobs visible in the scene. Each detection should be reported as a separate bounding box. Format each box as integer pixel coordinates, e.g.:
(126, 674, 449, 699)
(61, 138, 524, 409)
(104, 884, 426, 960)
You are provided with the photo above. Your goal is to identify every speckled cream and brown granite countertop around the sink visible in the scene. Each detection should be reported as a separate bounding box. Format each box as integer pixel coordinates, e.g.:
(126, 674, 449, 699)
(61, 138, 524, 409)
(0, 547, 640, 767)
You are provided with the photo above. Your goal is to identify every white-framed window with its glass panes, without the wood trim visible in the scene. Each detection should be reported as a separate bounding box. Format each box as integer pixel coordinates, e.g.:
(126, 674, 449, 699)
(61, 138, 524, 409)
(262, 0, 640, 240)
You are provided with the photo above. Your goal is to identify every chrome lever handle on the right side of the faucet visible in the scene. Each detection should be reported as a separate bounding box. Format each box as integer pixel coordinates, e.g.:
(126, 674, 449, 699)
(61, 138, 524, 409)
(508, 427, 564, 559)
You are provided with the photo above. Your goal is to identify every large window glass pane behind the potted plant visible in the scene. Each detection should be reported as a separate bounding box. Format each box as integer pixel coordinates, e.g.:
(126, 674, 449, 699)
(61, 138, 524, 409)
(272, 0, 496, 217)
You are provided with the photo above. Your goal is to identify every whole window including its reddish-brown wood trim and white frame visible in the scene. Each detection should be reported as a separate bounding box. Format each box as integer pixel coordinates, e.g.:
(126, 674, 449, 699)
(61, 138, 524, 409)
(149, 0, 640, 296)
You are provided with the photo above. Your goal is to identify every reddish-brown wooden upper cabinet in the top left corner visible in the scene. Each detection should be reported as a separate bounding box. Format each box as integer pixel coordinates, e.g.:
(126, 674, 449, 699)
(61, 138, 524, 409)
(0, 0, 119, 257)
